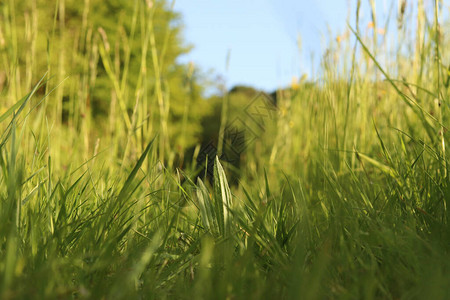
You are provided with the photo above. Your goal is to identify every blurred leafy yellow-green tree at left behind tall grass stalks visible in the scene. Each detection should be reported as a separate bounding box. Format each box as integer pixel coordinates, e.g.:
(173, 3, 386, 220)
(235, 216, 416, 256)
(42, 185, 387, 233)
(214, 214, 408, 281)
(0, 0, 204, 161)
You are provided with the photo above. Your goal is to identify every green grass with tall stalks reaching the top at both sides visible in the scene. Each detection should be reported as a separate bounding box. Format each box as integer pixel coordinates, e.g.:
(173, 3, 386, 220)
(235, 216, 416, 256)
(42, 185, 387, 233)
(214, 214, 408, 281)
(0, 0, 450, 299)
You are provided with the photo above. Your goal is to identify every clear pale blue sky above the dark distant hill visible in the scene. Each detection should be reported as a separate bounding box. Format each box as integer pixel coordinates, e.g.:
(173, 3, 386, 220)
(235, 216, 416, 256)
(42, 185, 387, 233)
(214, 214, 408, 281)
(174, 0, 422, 91)
